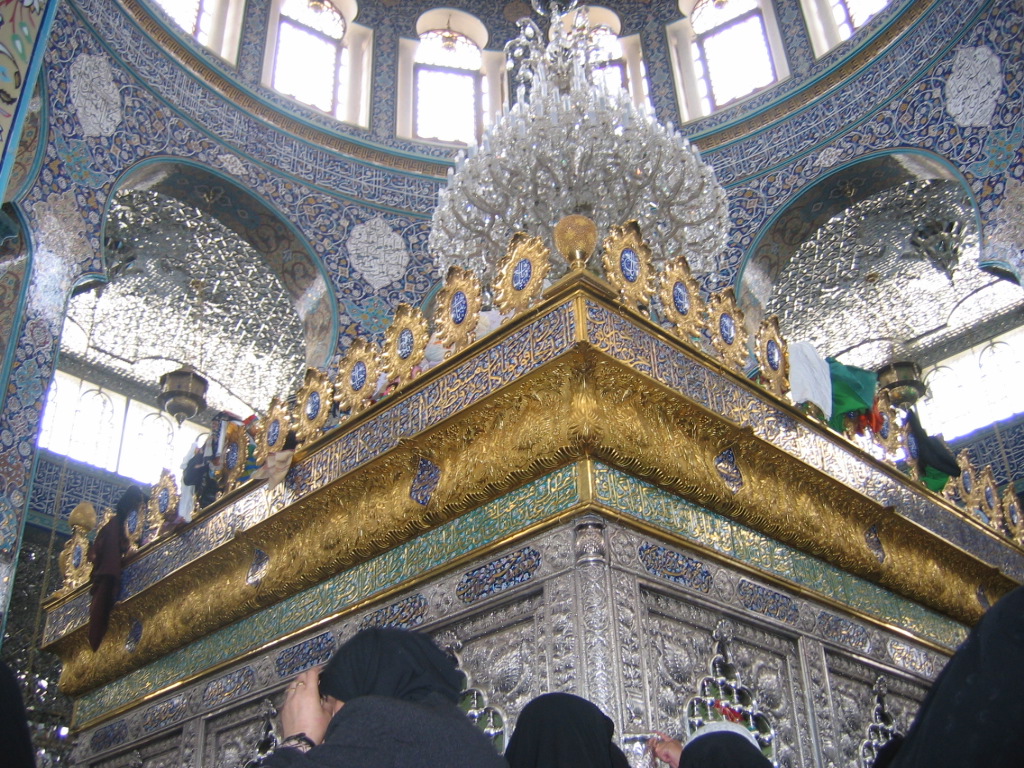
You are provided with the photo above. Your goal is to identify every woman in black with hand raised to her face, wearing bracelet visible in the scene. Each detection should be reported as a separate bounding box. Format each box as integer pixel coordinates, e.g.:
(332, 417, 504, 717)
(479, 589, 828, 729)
(263, 629, 505, 768)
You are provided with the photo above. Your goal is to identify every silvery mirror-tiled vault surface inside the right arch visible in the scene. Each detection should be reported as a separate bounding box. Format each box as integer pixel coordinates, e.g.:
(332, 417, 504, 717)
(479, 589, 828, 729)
(752, 179, 1024, 370)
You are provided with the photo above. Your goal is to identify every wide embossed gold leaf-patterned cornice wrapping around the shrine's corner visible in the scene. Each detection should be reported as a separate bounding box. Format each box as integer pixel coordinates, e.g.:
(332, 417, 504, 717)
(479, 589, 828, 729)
(48, 273, 1014, 695)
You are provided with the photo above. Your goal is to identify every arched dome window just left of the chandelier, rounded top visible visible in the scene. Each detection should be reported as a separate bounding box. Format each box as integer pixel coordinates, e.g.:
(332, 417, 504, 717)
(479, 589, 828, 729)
(397, 8, 505, 144)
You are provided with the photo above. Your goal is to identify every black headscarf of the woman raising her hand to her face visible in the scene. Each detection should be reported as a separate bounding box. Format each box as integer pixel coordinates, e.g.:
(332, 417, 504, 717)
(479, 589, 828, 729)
(319, 628, 466, 703)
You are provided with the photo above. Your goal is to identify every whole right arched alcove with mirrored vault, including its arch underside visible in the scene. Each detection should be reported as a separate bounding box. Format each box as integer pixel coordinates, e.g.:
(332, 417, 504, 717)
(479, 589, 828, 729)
(738, 150, 1024, 369)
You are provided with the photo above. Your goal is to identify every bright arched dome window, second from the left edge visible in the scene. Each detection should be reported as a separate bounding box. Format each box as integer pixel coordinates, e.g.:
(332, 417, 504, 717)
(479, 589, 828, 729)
(264, 0, 372, 126)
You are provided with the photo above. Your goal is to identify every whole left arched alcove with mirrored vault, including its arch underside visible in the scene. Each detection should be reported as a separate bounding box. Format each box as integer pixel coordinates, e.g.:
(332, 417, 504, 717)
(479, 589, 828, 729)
(61, 161, 337, 416)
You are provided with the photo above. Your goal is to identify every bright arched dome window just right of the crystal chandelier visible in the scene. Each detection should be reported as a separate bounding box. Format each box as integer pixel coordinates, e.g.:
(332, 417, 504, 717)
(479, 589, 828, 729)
(669, 0, 790, 120)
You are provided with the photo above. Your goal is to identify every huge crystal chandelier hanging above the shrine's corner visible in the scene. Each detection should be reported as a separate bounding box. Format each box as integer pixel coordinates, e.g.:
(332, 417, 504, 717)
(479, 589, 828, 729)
(428, 0, 727, 284)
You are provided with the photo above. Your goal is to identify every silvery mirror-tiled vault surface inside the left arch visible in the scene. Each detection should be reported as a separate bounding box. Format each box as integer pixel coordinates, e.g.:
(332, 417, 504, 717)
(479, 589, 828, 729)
(60, 189, 306, 417)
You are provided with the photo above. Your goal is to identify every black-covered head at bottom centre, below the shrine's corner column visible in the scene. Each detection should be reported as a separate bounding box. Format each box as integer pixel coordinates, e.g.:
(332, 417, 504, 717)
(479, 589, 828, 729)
(505, 693, 629, 768)
